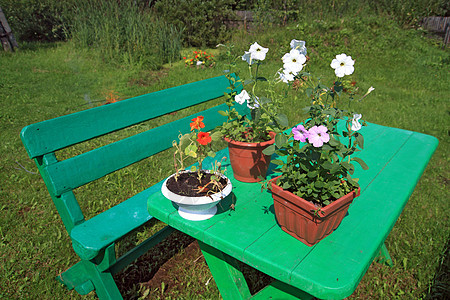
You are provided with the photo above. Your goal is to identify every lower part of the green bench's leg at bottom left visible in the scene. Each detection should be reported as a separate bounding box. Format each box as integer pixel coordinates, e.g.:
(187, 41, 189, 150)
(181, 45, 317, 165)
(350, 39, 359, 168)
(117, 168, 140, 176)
(57, 260, 122, 299)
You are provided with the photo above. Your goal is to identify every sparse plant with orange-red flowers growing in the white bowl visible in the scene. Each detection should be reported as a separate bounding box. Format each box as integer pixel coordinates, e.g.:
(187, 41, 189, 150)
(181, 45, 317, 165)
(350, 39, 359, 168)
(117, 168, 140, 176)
(172, 116, 222, 192)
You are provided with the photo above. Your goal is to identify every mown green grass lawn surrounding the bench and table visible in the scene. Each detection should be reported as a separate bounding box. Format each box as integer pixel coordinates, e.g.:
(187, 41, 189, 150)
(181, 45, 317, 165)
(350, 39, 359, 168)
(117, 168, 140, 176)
(0, 17, 450, 299)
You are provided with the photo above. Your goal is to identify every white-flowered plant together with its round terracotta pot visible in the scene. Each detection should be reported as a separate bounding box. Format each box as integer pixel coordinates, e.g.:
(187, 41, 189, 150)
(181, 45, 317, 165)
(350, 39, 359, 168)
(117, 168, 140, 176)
(220, 40, 304, 182)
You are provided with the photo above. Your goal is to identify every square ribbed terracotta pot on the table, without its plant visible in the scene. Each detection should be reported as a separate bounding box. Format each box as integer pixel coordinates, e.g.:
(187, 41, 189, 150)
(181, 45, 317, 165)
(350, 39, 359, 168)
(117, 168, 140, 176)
(271, 176, 360, 246)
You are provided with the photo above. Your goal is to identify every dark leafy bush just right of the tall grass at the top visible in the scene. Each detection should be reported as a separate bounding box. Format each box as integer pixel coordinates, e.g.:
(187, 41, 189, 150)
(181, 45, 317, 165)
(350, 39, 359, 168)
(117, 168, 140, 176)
(155, 0, 234, 47)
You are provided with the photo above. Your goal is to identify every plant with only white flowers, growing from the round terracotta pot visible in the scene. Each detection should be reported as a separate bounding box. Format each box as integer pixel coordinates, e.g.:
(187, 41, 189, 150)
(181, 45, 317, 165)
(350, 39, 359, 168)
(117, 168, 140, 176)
(220, 40, 306, 142)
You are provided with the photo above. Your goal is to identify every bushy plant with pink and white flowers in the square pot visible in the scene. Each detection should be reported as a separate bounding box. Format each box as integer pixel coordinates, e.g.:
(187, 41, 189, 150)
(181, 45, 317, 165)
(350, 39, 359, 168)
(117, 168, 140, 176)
(265, 43, 373, 209)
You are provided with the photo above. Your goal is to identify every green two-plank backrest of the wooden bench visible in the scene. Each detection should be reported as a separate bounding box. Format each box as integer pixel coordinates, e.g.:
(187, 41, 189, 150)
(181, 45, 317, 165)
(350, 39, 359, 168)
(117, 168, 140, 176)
(21, 76, 244, 232)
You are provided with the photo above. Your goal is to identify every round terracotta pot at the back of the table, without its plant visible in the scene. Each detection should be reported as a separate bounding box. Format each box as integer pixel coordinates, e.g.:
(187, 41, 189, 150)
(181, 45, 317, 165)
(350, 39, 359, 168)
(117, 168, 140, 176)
(224, 132, 276, 182)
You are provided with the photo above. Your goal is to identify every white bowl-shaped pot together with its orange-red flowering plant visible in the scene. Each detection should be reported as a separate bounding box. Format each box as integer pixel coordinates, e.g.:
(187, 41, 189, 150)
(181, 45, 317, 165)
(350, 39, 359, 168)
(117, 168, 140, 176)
(161, 116, 232, 221)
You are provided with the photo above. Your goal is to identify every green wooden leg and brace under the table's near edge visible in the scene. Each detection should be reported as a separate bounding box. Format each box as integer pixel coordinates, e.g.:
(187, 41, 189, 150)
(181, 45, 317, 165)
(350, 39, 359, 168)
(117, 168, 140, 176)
(198, 241, 314, 300)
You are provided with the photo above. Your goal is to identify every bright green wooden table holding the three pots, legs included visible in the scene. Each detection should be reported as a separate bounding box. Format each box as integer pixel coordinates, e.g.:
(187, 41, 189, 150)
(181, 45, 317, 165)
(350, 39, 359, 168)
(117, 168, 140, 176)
(148, 124, 438, 299)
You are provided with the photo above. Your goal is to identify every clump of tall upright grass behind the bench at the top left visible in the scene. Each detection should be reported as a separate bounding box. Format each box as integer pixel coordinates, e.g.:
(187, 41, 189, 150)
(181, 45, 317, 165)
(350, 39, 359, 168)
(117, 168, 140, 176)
(69, 0, 182, 69)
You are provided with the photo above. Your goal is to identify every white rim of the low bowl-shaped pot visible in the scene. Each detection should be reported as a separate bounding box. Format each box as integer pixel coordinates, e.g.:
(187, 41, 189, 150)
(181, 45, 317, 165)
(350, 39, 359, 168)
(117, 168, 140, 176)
(161, 170, 233, 205)
